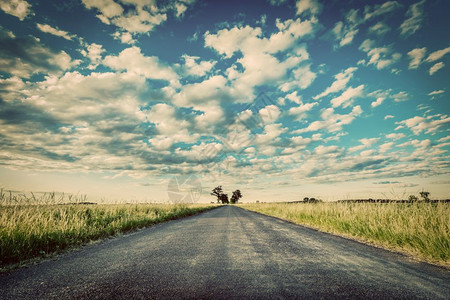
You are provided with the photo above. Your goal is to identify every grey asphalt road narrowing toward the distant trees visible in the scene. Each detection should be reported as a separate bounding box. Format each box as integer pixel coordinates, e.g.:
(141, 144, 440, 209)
(0, 206, 450, 299)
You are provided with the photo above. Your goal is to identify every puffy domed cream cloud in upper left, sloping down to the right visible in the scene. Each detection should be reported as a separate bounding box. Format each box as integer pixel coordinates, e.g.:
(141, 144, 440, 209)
(103, 46, 178, 83)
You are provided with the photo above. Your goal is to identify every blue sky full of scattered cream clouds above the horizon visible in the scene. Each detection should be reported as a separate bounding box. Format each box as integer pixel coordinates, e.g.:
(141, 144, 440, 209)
(0, 0, 450, 202)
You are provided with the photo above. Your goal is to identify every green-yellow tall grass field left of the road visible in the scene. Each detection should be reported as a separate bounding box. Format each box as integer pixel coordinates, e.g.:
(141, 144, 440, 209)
(0, 204, 214, 268)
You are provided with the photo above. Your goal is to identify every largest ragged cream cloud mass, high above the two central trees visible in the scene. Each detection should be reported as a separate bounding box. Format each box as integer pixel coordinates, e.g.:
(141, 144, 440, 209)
(204, 18, 317, 99)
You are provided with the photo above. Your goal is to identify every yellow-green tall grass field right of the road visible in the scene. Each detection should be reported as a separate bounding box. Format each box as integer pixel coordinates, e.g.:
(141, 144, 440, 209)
(243, 202, 450, 267)
